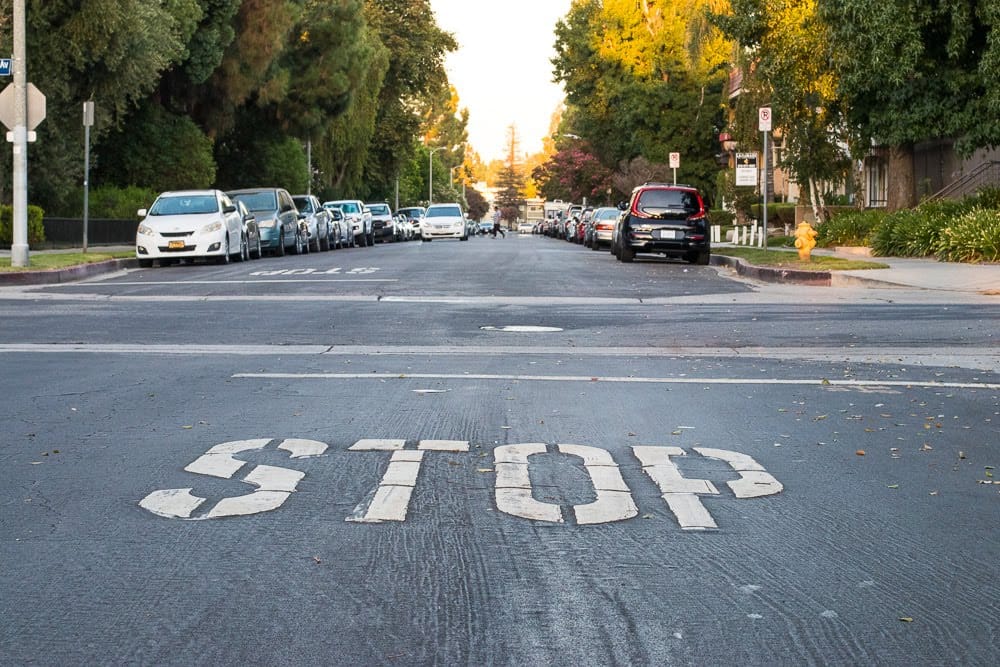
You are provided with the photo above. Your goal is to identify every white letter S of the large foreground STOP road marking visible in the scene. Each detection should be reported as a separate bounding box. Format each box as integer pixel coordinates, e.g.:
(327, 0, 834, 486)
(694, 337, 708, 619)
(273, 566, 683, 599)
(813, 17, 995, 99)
(139, 438, 327, 520)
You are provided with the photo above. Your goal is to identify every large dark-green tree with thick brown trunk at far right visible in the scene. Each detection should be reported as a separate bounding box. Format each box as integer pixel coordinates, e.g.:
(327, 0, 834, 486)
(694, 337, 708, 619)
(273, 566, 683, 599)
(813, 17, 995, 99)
(818, 0, 1000, 209)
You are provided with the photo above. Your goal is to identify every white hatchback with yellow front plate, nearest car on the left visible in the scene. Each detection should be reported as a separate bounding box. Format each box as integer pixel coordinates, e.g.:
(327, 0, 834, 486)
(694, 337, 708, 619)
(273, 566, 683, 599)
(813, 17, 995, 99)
(135, 190, 249, 267)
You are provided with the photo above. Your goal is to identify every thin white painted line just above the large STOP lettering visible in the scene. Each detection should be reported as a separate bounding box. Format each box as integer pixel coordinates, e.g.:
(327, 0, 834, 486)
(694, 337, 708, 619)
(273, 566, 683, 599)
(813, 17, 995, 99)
(232, 373, 1000, 389)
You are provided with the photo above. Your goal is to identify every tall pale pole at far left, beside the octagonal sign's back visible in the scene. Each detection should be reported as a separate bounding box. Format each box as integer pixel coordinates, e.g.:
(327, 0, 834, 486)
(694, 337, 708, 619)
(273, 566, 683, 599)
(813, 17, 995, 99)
(10, 0, 30, 267)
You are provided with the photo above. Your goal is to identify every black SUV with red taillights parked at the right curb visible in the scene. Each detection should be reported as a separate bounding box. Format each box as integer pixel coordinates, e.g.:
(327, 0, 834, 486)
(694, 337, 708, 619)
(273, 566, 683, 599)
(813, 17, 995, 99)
(611, 183, 712, 264)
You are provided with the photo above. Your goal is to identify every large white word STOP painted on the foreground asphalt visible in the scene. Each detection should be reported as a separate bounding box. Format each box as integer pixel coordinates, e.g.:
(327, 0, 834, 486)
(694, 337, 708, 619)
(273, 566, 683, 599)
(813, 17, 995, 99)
(139, 438, 784, 530)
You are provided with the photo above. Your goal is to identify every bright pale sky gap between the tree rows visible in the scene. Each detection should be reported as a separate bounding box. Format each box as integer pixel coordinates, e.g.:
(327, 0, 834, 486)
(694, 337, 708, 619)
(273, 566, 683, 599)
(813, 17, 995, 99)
(430, 0, 571, 162)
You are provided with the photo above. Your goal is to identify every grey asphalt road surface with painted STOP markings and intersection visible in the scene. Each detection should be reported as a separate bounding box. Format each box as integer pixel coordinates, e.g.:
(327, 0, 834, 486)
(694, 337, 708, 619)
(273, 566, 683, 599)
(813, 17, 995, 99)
(0, 234, 1000, 666)
